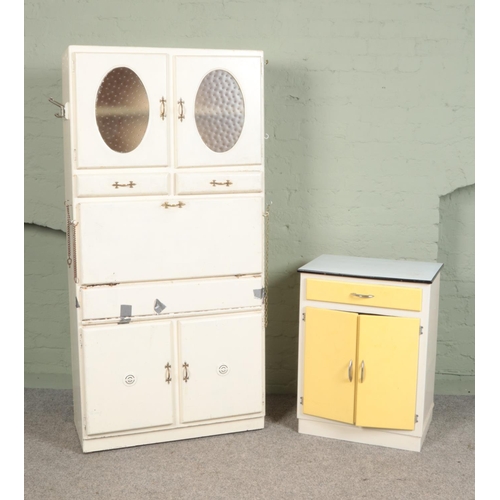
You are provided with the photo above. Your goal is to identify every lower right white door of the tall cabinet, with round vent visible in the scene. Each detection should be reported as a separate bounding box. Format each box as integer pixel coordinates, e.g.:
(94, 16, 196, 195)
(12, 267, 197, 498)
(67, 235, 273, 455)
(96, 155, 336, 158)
(178, 312, 264, 422)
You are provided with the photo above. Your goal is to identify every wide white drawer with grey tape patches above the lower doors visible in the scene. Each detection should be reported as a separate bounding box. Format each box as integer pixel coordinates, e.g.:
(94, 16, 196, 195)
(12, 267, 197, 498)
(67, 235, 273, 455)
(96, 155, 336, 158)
(80, 276, 262, 320)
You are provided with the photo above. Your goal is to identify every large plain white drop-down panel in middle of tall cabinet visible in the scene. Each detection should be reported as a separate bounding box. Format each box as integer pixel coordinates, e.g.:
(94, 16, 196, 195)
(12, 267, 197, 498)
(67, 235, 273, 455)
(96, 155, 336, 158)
(77, 195, 264, 284)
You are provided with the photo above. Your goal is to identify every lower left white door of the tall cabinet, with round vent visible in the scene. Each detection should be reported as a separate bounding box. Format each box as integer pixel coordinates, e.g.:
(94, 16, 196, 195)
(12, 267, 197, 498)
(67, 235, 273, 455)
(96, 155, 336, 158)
(81, 321, 177, 435)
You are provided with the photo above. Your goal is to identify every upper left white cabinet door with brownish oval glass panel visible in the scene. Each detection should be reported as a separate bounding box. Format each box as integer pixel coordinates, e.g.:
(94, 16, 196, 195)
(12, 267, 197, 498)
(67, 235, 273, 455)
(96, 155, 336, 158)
(73, 53, 168, 168)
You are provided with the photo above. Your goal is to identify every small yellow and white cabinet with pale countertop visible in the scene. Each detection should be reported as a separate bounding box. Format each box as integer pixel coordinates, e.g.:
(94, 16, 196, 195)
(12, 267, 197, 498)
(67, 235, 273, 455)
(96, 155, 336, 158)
(297, 256, 442, 451)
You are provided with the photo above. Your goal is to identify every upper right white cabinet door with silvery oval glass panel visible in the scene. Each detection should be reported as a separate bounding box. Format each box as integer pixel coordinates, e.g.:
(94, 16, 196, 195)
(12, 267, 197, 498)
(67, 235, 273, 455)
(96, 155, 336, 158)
(174, 56, 263, 167)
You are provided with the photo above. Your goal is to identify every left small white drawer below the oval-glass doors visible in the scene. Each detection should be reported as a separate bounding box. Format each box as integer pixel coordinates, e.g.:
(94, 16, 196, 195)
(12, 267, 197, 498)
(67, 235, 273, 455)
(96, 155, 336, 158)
(75, 172, 169, 198)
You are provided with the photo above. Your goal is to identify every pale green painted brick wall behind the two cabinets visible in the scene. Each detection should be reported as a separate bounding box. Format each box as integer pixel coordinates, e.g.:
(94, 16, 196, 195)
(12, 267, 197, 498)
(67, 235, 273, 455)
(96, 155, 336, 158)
(25, 0, 474, 393)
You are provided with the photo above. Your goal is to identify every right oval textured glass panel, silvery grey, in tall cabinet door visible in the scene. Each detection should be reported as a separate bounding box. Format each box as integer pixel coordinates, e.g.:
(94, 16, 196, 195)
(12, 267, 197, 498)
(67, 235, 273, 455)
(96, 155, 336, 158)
(194, 69, 245, 153)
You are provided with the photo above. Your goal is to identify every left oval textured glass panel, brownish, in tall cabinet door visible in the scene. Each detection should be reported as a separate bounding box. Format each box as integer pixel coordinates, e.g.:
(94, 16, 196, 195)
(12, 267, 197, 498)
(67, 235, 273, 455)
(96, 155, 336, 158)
(95, 67, 149, 153)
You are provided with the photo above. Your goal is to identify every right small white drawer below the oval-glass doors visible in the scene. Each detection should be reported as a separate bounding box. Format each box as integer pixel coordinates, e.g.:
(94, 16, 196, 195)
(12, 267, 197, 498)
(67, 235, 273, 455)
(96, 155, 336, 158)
(175, 171, 262, 194)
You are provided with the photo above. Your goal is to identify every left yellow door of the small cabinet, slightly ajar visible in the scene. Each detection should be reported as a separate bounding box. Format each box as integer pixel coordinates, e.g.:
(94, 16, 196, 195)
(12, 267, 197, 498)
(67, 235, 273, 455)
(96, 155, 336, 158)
(303, 307, 358, 424)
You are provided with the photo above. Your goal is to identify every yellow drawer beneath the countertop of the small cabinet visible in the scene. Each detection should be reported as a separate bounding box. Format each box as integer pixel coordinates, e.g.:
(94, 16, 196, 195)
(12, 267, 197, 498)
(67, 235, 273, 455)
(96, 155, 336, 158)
(306, 279, 422, 311)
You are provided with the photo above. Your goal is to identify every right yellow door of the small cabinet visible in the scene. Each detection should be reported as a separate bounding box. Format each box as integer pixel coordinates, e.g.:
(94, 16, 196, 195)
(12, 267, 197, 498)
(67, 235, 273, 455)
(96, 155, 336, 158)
(355, 315, 420, 430)
